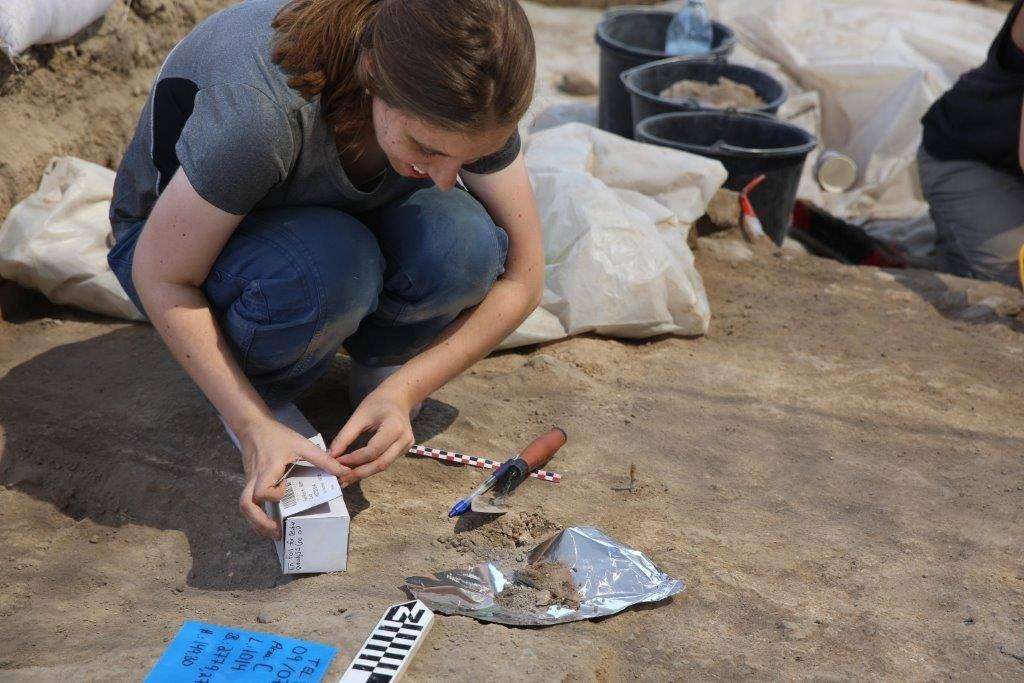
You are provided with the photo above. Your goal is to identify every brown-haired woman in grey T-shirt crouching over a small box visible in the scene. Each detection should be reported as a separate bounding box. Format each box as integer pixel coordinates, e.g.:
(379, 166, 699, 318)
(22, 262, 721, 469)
(109, 0, 544, 537)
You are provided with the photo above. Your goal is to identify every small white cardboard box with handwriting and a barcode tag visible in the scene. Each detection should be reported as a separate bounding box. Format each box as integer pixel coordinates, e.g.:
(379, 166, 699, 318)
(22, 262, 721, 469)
(264, 434, 350, 573)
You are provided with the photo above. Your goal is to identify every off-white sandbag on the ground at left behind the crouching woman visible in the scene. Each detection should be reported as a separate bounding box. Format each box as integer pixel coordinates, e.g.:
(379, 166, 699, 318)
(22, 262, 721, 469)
(0, 157, 142, 321)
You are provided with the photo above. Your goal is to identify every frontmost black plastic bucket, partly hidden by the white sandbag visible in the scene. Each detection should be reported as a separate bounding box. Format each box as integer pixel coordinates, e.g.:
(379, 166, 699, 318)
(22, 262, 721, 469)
(637, 111, 818, 245)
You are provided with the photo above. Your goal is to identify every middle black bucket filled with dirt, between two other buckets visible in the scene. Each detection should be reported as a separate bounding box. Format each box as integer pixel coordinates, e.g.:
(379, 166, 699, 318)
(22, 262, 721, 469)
(621, 57, 786, 132)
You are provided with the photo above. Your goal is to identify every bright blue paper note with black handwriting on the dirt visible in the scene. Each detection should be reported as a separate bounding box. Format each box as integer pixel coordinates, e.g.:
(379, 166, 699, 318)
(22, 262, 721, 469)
(145, 622, 337, 683)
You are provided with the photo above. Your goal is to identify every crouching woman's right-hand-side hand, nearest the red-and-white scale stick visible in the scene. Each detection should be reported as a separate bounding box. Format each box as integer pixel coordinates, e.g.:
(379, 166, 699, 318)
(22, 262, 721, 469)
(330, 389, 414, 485)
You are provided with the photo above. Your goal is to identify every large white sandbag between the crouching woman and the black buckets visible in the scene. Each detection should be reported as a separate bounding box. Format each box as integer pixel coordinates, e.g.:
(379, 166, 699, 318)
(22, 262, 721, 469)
(502, 123, 726, 348)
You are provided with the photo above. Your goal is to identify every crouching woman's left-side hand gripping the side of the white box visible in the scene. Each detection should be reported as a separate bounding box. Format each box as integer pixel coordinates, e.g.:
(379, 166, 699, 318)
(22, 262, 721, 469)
(239, 420, 348, 539)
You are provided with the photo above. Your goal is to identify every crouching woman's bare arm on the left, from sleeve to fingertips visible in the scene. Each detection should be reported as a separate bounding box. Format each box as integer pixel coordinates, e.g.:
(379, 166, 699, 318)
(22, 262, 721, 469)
(132, 170, 347, 538)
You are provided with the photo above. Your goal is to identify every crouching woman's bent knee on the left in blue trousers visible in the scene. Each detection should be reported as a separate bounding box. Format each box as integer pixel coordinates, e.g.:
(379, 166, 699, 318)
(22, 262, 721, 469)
(205, 208, 383, 374)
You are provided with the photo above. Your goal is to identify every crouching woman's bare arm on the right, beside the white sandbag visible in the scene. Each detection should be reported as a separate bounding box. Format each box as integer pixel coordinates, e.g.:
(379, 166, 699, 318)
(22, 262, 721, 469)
(331, 154, 544, 483)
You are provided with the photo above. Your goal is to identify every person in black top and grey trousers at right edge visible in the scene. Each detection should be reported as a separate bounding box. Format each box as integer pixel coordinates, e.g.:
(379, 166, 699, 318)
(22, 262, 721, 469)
(918, 0, 1024, 286)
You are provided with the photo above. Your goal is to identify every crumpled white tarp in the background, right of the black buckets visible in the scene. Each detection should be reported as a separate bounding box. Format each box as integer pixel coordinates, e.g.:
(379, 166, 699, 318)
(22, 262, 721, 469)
(710, 0, 1006, 227)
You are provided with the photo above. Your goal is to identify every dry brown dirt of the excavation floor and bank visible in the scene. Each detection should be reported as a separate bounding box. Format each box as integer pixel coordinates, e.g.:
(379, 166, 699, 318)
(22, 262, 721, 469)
(0, 1, 1024, 681)
